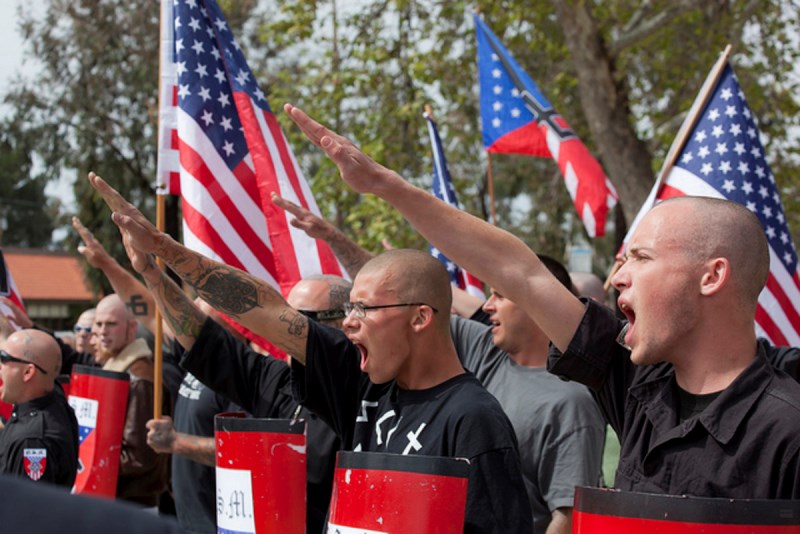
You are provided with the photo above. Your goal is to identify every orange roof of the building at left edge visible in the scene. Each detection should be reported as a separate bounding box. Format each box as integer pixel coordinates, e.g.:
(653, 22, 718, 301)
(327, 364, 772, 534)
(3, 247, 95, 301)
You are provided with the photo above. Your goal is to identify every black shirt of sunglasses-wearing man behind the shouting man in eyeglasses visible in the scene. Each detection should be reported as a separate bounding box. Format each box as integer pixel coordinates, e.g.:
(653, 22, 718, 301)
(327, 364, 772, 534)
(181, 319, 339, 533)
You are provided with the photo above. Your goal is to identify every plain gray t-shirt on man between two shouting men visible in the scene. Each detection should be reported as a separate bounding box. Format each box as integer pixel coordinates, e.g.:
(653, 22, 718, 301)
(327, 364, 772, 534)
(450, 317, 605, 532)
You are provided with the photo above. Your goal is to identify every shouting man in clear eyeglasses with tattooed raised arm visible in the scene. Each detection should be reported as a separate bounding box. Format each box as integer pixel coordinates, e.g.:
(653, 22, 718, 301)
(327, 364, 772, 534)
(90, 175, 532, 533)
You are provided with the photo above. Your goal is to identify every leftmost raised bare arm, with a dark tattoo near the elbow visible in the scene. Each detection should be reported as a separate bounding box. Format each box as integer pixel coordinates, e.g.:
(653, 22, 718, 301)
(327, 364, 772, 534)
(72, 217, 162, 332)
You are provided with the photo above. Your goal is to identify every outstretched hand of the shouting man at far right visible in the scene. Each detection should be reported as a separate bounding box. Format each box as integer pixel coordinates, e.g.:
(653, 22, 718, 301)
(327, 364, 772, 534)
(283, 104, 403, 198)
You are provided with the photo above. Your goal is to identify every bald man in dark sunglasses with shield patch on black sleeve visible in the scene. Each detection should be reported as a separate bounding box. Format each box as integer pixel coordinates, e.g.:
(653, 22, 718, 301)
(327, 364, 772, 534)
(0, 330, 78, 487)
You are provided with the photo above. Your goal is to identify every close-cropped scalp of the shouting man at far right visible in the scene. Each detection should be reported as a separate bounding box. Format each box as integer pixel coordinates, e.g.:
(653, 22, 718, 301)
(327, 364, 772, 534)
(651, 197, 769, 306)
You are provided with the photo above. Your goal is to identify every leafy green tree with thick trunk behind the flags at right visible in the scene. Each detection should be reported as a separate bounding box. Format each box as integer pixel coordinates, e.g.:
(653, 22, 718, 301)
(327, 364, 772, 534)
(262, 0, 800, 272)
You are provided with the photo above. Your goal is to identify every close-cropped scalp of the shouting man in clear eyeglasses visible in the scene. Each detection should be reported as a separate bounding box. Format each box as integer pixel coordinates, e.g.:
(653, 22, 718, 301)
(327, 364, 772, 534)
(359, 249, 453, 322)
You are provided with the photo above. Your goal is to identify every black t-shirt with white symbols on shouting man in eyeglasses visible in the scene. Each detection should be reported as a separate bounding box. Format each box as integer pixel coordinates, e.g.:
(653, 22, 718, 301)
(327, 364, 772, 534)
(292, 321, 532, 533)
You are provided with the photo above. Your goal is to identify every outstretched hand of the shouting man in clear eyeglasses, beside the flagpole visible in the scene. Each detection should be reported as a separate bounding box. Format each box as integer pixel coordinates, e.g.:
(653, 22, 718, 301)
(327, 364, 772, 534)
(89, 172, 166, 260)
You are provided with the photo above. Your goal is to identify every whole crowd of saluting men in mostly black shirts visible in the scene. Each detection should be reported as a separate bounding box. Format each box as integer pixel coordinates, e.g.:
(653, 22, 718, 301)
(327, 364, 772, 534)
(0, 105, 800, 533)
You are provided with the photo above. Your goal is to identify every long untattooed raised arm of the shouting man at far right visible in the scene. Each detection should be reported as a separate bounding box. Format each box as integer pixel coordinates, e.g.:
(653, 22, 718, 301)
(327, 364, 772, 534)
(284, 104, 584, 356)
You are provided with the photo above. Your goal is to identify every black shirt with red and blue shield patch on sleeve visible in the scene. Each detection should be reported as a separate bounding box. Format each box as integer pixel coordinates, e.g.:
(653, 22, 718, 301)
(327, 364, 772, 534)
(0, 385, 78, 487)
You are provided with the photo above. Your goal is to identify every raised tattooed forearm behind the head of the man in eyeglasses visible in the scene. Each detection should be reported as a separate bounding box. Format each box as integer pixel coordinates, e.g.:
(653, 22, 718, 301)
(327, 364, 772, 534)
(272, 193, 372, 278)
